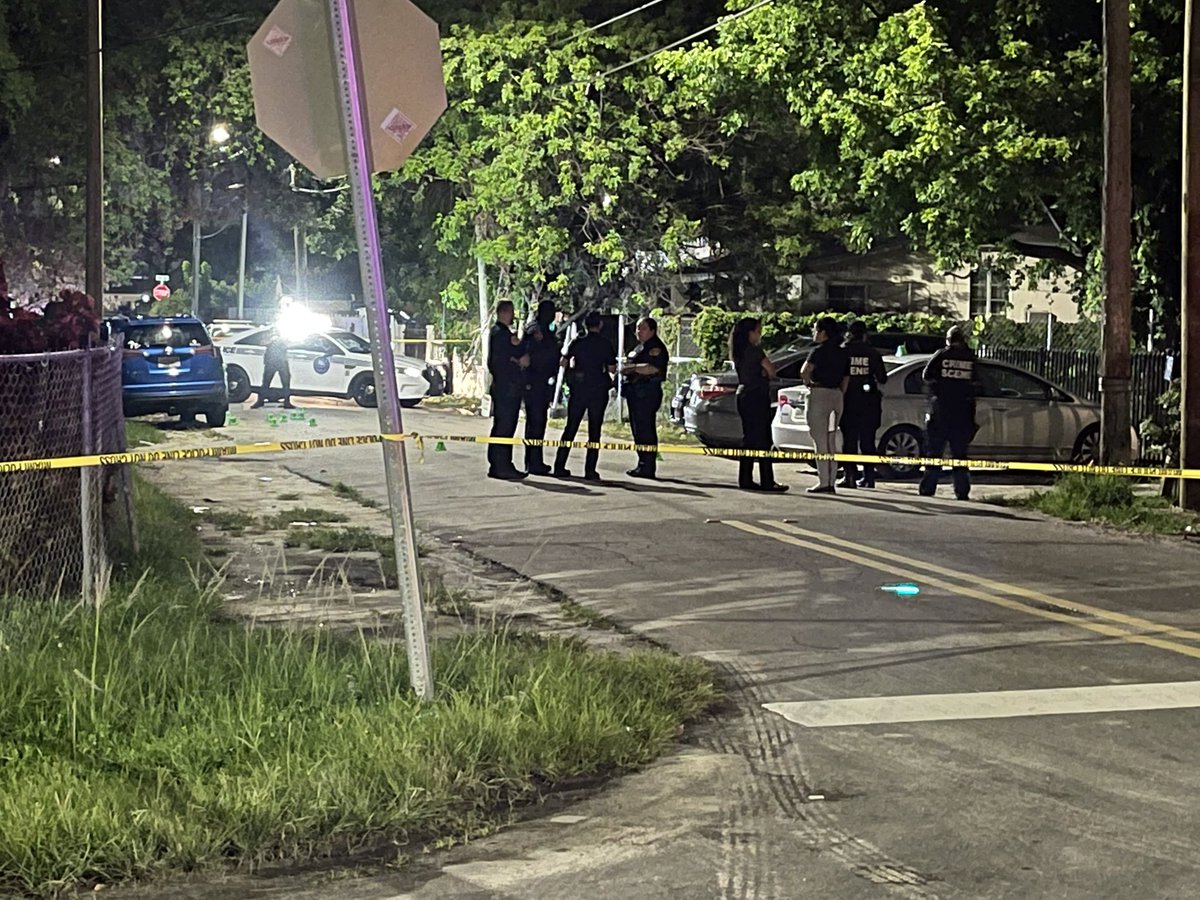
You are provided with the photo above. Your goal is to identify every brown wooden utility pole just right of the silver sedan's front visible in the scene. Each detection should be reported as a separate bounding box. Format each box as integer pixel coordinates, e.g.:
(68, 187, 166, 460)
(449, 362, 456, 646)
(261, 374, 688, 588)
(1100, 0, 1133, 466)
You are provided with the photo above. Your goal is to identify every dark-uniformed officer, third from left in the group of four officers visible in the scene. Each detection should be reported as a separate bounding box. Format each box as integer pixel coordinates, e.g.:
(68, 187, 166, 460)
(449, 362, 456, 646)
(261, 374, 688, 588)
(554, 312, 617, 481)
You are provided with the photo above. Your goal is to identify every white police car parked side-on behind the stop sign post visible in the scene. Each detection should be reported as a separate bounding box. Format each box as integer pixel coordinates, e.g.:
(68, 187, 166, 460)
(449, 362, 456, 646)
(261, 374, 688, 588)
(216, 328, 444, 407)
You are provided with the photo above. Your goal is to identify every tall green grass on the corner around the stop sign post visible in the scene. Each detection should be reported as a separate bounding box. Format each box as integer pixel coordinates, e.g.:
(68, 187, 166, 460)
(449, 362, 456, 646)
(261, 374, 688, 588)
(0, 481, 715, 896)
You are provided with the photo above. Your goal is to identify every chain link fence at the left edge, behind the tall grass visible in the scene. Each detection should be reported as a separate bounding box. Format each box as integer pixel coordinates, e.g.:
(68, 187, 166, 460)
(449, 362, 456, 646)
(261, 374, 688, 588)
(0, 347, 128, 598)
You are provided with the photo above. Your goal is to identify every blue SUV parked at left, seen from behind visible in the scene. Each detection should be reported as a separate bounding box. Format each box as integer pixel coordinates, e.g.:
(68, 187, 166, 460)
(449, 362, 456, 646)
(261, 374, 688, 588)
(109, 316, 229, 427)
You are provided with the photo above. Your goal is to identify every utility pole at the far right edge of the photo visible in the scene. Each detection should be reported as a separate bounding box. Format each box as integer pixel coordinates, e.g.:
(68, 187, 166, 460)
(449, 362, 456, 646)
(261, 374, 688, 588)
(1180, 0, 1200, 509)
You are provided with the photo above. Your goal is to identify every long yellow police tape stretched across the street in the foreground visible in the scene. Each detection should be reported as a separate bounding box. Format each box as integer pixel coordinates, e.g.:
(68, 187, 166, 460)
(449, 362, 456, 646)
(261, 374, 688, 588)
(0, 432, 1200, 479)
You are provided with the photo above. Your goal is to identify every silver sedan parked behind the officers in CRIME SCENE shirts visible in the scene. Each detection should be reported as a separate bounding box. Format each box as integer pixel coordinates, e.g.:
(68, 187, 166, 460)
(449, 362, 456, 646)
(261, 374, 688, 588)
(772, 355, 1100, 478)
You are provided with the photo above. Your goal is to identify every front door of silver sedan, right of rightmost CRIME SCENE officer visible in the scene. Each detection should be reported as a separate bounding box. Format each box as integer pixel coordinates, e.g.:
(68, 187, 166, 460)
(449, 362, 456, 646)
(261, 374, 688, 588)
(979, 362, 1066, 460)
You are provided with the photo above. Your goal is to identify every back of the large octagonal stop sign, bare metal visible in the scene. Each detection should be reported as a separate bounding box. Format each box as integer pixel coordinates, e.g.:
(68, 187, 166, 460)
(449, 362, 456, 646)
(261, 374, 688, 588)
(246, 0, 446, 178)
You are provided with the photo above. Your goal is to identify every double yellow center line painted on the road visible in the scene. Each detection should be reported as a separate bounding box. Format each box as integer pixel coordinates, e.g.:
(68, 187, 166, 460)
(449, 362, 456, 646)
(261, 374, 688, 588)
(721, 518, 1200, 659)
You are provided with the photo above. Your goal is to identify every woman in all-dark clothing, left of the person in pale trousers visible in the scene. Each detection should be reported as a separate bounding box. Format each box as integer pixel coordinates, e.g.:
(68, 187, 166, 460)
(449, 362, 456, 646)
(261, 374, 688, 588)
(730, 316, 787, 493)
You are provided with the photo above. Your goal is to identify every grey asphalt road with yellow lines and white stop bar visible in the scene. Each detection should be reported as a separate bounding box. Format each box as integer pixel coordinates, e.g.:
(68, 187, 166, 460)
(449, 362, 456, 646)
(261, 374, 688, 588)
(220, 407, 1200, 898)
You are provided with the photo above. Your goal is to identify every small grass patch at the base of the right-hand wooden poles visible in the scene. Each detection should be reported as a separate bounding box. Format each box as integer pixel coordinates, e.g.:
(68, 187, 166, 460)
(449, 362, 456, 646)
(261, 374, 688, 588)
(1003, 473, 1200, 534)
